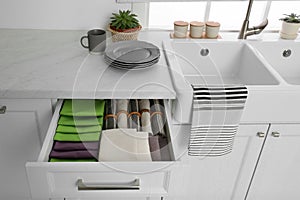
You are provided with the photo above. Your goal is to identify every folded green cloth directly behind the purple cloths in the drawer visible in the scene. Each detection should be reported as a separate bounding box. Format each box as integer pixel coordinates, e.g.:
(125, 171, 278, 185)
(53, 132, 100, 142)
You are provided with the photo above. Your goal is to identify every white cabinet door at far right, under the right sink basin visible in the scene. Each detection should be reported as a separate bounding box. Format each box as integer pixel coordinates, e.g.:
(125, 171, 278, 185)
(247, 124, 300, 200)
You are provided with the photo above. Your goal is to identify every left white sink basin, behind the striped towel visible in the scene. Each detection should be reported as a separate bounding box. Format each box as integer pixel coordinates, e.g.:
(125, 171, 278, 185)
(170, 40, 279, 85)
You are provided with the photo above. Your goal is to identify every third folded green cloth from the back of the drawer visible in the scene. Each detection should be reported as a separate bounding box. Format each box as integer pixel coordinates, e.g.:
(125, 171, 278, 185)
(56, 125, 102, 133)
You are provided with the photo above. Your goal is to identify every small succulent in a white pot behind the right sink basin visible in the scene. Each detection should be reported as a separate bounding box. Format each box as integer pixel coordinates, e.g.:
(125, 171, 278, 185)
(279, 13, 300, 40)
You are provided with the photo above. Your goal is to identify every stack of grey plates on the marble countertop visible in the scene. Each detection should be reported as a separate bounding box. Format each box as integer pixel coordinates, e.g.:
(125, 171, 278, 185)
(104, 40, 160, 69)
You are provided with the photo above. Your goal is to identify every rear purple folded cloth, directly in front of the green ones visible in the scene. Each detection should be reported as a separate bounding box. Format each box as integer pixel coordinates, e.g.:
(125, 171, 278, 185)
(52, 141, 99, 151)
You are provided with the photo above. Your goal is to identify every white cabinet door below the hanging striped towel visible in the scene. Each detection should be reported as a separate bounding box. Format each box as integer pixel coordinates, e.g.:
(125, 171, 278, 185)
(180, 124, 269, 200)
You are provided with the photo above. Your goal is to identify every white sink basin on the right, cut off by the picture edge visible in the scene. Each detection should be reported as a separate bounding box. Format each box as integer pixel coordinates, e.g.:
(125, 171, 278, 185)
(253, 41, 300, 85)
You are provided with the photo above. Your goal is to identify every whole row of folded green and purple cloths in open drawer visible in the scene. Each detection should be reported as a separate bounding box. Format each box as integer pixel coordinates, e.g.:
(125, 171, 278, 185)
(49, 100, 105, 162)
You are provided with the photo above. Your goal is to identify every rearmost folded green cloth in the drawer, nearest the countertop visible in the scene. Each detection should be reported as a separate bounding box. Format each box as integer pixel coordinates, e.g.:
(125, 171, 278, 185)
(60, 99, 105, 117)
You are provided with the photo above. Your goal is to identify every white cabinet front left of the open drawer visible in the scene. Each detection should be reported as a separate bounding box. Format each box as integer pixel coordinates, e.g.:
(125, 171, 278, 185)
(0, 99, 52, 200)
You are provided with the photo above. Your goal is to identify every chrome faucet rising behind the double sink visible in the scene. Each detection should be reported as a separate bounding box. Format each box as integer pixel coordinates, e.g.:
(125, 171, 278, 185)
(238, 0, 268, 39)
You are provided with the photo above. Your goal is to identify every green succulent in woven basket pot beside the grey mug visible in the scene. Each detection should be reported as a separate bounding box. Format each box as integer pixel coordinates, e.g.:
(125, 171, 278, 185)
(108, 10, 142, 42)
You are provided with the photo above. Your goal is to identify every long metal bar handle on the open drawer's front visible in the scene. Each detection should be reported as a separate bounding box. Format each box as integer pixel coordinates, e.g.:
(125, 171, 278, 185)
(77, 179, 140, 190)
